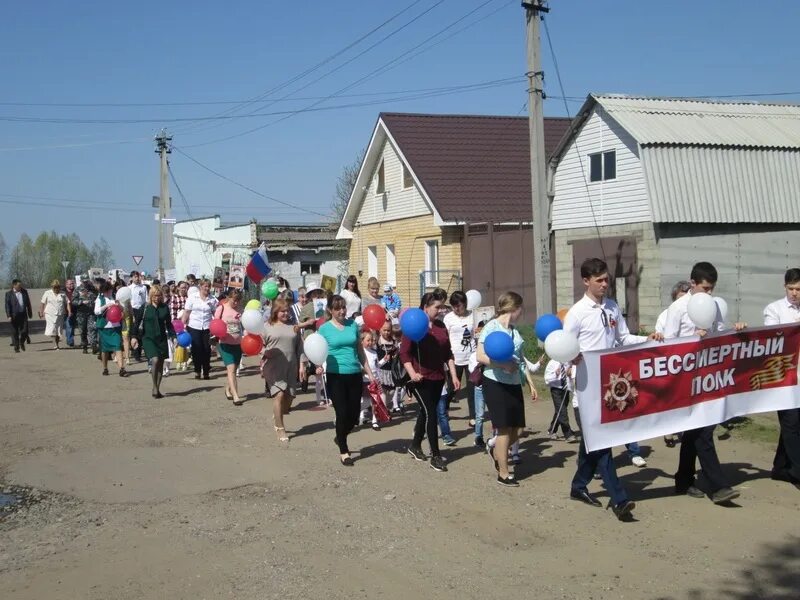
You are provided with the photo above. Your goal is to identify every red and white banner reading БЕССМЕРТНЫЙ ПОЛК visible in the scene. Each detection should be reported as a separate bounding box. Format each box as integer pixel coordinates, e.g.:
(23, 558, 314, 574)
(577, 324, 800, 451)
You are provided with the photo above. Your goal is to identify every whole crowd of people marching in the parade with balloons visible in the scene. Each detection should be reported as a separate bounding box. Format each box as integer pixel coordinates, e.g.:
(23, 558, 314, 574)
(6, 258, 800, 520)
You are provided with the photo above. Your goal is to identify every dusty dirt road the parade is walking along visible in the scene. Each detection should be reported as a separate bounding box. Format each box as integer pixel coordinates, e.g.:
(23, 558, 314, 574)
(0, 336, 800, 600)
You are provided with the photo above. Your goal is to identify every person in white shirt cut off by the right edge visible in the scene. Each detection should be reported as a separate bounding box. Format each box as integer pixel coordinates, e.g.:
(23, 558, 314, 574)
(764, 269, 800, 489)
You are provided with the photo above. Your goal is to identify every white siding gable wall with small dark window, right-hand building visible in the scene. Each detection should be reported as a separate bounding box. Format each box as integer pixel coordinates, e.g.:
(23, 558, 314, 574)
(552, 106, 652, 230)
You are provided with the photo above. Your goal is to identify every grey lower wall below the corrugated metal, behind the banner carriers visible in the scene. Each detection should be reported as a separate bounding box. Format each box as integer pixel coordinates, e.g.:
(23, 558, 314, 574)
(657, 224, 800, 326)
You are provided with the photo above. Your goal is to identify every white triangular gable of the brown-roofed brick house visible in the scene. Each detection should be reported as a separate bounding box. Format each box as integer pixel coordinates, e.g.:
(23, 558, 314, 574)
(356, 140, 431, 225)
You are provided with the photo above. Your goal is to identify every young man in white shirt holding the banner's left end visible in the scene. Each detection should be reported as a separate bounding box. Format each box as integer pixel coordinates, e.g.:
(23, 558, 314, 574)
(564, 258, 662, 521)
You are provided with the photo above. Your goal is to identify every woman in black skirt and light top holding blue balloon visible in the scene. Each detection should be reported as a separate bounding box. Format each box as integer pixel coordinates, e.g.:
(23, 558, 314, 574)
(477, 292, 525, 486)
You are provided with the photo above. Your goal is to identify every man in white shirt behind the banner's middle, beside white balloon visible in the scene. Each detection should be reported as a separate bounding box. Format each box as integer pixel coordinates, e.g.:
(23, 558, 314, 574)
(664, 262, 746, 504)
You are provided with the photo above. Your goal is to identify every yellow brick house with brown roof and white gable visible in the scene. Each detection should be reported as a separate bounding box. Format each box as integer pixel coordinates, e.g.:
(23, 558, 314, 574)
(337, 113, 570, 320)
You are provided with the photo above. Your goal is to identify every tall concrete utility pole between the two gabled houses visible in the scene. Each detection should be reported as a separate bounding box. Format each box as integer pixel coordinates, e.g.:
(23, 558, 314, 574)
(522, 0, 553, 318)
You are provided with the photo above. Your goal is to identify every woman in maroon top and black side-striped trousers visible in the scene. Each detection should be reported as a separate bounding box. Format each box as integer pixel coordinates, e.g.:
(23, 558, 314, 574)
(400, 293, 461, 471)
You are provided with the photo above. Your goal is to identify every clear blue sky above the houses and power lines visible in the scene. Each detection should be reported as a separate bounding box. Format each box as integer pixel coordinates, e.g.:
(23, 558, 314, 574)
(0, 0, 800, 269)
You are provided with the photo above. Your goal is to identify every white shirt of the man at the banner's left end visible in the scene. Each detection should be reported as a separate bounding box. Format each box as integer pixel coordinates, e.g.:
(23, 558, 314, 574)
(564, 295, 647, 352)
